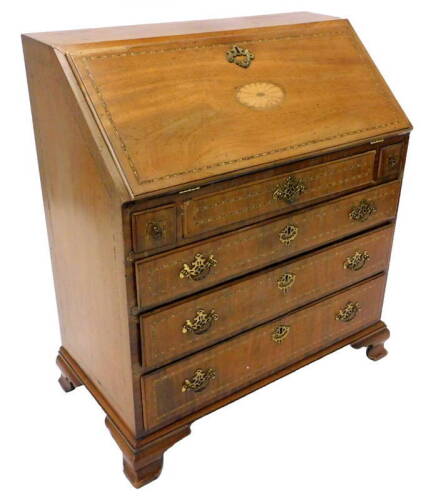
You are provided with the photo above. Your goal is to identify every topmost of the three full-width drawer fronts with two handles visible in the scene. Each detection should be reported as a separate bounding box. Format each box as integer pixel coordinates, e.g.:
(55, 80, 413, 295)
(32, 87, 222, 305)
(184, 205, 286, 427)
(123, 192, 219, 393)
(136, 181, 400, 308)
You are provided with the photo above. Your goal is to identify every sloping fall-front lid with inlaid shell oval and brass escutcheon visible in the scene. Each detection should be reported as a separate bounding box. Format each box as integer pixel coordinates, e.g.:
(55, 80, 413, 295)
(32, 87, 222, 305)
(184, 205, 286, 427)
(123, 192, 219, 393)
(69, 20, 410, 196)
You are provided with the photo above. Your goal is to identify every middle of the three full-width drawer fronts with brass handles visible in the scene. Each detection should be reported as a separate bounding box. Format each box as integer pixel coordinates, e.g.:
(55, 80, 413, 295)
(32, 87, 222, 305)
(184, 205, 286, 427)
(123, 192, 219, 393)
(140, 226, 393, 370)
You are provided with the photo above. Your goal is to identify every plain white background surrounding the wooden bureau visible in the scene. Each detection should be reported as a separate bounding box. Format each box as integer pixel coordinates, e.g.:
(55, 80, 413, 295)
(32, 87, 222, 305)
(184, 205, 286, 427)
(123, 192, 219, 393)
(0, 0, 431, 500)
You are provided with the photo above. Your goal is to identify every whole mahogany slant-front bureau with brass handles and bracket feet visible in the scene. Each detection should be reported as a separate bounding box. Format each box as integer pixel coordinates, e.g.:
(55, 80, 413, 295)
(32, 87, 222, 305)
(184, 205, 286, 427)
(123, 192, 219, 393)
(23, 13, 411, 487)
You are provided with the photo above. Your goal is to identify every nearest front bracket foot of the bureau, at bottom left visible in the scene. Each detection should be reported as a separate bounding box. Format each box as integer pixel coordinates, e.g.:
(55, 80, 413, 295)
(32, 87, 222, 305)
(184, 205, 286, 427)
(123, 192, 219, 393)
(105, 417, 190, 488)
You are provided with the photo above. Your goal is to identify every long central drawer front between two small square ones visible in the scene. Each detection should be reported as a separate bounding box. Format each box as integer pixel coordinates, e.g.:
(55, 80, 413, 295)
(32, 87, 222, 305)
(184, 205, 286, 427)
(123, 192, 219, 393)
(183, 151, 375, 237)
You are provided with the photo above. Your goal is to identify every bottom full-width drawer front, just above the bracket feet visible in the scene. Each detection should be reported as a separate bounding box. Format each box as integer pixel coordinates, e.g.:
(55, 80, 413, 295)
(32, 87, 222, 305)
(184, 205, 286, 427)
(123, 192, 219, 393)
(142, 276, 385, 428)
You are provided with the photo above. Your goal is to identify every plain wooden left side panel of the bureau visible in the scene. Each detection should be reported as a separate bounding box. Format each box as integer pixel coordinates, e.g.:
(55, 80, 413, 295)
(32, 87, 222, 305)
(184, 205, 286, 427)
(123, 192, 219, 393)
(23, 37, 136, 432)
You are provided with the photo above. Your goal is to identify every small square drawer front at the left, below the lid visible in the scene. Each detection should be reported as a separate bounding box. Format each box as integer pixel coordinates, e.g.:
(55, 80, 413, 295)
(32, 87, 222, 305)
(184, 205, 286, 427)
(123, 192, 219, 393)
(132, 205, 177, 252)
